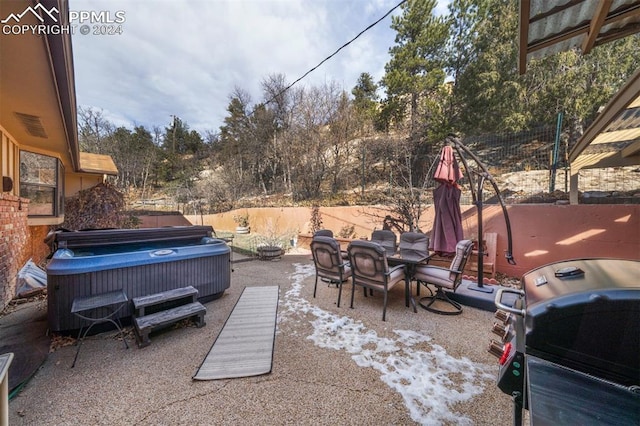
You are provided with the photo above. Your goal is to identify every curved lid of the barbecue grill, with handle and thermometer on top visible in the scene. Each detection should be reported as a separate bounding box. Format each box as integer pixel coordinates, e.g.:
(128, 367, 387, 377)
(522, 259, 640, 386)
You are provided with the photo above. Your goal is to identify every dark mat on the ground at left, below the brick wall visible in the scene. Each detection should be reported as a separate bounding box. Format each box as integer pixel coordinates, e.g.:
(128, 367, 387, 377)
(0, 301, 51, 393)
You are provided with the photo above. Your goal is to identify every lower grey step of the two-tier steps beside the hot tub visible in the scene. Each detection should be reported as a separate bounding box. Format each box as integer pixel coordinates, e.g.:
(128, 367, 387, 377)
(133, 302, 207, 348)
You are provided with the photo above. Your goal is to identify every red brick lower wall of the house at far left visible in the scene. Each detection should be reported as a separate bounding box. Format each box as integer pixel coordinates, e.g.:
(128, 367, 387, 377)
(0, 194, 30, 310)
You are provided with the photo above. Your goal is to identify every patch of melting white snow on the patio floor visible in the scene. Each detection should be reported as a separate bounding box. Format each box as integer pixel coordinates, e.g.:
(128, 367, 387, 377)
(278, 263, 496, 425)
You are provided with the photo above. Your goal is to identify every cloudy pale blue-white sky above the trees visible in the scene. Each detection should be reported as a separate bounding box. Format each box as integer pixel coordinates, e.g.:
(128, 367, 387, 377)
(69, 0, 448, 136)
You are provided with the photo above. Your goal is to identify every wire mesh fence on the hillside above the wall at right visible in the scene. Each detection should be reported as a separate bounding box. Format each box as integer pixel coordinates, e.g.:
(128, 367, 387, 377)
(425, 127, 640, 204)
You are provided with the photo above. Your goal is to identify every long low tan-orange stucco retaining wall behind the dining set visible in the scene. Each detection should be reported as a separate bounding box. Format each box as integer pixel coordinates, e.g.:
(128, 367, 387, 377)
(178, 204, 640, 277)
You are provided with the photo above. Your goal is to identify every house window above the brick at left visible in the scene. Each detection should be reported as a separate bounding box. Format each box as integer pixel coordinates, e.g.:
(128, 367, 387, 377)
(20, 151, 64, 216)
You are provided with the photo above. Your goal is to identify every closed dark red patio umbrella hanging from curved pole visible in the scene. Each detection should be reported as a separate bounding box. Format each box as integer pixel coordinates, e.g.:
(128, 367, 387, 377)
(429, 145, 463, 256)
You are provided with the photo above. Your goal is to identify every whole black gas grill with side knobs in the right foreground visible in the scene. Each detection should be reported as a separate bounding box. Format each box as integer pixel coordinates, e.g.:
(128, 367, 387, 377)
(489, 259, 640, 424)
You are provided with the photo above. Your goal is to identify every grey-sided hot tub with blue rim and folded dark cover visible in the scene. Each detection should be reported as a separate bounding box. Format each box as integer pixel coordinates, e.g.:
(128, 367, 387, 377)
(46, 226, 231, 332)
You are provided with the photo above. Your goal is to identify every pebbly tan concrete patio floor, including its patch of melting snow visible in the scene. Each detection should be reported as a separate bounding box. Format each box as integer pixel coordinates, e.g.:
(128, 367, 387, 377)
(9, 255, 512, 425)
